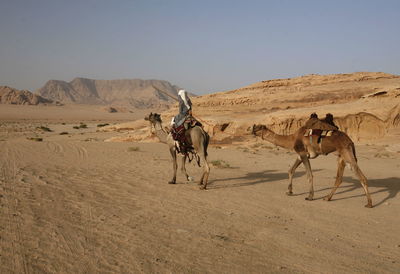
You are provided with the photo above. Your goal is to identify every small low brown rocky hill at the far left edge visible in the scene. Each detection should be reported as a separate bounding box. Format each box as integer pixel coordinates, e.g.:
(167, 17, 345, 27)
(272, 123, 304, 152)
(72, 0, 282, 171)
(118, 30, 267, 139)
(0, 86, 52, 105)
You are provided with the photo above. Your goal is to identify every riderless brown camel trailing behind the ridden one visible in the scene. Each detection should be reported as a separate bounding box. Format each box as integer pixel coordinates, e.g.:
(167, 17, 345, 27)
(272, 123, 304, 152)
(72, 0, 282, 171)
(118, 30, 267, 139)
(252, 125, 372, 208)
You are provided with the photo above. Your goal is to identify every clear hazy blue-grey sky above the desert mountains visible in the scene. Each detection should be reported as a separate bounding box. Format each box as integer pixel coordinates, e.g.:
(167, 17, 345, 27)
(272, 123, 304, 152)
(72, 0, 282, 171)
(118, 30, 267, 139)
(0, 0, 400, 94)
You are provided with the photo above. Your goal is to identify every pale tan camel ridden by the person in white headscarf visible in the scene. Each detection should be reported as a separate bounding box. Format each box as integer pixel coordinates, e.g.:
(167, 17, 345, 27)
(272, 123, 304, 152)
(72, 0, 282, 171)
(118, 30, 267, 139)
(145, 113, 210, 189)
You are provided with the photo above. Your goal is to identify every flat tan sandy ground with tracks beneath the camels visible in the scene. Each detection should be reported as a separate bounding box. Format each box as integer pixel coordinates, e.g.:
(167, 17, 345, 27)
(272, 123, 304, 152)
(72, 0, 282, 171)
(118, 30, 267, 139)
(0, 106, 400, 273)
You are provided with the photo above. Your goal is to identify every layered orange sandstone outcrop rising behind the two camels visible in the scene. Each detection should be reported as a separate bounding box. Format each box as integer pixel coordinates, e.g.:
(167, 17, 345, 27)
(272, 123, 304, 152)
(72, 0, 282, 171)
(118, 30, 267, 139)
(101, 72, 400, 144)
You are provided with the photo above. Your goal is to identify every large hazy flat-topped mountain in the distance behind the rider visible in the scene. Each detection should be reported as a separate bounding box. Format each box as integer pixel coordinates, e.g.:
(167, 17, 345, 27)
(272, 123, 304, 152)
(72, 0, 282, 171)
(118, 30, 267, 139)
(35, 78, 183, 108)
